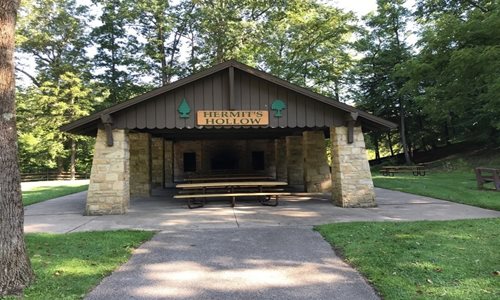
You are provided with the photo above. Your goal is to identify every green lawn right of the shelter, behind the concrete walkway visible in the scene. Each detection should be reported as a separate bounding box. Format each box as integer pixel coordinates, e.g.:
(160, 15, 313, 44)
(373, 170, 500, 210)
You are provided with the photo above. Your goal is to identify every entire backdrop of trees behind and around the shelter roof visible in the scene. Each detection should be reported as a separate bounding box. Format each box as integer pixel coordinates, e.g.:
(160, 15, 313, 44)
(16, 0, 500, 171)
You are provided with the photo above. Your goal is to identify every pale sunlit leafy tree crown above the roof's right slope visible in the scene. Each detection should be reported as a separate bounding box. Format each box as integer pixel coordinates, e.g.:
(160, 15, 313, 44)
(255, 0, 355, 101)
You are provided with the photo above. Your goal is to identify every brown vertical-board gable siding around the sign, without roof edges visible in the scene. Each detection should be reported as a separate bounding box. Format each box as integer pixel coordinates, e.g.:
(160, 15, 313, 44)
(112, 69, 346, 129)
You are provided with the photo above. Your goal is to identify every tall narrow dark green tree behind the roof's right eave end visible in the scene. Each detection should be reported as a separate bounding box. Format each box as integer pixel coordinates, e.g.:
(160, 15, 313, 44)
(356, 0, 413, 163)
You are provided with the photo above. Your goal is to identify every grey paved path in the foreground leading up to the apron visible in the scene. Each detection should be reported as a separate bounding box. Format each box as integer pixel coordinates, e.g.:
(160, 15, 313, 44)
(87, 227, 378, 300)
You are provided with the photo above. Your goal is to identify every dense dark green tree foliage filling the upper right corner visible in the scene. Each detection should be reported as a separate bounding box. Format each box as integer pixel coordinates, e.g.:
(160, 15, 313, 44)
(408, 0, 500, 142)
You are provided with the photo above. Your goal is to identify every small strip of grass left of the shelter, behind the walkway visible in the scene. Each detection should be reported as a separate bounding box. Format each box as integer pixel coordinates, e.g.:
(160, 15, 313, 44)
(23, 184, 89, 206)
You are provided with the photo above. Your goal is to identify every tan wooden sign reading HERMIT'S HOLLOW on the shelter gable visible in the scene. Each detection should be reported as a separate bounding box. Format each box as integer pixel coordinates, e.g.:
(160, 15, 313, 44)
(196, 110, 269, 126)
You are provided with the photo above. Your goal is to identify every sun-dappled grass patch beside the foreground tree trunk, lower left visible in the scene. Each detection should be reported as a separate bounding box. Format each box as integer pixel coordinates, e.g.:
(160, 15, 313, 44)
(4, 231, 154, 299)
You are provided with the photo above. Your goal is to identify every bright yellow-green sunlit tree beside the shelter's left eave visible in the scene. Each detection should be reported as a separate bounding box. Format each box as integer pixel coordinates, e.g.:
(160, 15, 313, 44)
(17, 72, 107, 175)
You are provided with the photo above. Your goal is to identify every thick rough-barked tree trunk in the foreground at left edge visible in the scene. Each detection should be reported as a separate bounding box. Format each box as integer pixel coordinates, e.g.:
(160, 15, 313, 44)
(0, 0, 34, 296)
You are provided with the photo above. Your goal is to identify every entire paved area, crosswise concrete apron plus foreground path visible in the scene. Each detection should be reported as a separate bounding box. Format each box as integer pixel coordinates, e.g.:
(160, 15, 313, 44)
(25, 189, 500, 300)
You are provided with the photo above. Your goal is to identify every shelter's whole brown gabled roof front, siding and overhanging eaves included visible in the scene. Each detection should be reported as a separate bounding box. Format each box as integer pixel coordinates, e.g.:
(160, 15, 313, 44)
(61, 60, 397, 135)
